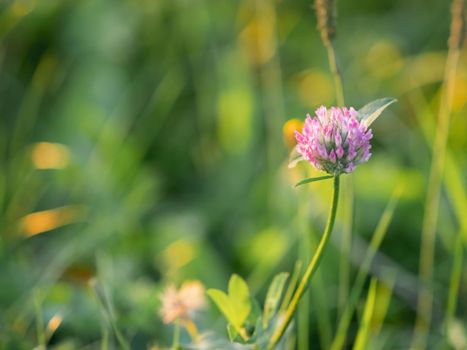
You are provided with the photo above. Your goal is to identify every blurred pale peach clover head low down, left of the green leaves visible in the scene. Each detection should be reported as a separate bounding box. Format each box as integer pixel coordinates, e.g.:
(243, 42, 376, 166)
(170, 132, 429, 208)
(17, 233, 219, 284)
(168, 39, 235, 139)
(160, 281, 206, 324)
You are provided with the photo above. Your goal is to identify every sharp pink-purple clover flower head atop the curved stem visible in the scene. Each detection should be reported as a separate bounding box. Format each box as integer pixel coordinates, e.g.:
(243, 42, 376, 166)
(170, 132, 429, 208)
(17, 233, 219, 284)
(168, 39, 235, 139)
(295, 106, 373, 175)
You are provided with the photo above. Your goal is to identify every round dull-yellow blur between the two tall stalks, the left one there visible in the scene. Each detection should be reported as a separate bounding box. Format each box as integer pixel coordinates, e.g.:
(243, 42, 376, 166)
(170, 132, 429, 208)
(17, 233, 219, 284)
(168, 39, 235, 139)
(366, 40, 404, 79)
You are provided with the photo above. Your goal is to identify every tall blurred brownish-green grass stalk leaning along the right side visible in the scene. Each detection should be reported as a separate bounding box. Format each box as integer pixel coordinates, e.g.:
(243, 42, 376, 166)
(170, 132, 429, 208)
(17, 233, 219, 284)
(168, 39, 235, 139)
(412, 0, 464, 349)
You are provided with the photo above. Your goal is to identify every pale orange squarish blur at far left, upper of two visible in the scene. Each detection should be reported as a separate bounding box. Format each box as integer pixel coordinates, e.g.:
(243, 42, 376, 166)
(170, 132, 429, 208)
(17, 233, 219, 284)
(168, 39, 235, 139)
(31, 142, 70, 169)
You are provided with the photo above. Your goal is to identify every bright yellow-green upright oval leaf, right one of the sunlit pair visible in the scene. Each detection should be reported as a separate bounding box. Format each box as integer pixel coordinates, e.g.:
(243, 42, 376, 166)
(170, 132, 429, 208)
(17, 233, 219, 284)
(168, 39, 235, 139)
(229, 274, 251, 327)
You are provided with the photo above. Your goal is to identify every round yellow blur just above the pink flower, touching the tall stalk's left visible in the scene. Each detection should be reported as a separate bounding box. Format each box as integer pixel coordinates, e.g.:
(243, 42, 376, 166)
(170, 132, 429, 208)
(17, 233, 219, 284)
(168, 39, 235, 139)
(297, 70, 334, 108)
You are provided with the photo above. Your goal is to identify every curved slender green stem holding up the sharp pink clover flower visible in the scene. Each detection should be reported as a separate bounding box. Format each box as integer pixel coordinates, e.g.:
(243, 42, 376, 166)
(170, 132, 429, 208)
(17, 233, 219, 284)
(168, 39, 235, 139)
(268, 176, 339, 350)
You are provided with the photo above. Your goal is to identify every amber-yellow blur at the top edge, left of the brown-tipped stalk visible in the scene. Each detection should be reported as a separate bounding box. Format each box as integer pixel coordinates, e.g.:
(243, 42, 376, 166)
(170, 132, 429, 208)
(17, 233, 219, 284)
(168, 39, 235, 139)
(239, 6, 276, 64)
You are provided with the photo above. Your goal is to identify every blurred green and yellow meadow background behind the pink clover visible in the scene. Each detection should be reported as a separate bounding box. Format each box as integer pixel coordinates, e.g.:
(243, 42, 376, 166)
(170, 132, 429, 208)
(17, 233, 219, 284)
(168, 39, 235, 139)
(0, 0, 467, 350)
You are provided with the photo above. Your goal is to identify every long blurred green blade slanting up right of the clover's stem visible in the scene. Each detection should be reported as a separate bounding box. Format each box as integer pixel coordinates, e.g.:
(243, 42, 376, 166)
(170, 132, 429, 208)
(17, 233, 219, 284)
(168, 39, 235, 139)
(331, 188, 401, 350)
